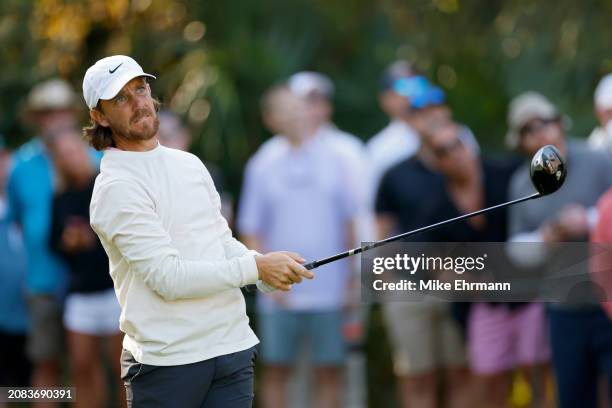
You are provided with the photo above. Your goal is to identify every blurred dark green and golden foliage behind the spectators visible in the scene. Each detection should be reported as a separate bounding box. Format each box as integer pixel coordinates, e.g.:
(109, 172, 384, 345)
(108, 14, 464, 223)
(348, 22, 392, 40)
(0, 0, 612, 406)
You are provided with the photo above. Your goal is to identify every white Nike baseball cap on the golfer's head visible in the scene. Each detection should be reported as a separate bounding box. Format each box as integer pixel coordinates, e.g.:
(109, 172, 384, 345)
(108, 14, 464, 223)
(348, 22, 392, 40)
(83, 55, 155, 109)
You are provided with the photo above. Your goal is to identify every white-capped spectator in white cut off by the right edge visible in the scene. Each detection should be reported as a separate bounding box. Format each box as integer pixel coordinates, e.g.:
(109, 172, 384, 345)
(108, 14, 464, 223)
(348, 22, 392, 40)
(588, 74, 612, 154)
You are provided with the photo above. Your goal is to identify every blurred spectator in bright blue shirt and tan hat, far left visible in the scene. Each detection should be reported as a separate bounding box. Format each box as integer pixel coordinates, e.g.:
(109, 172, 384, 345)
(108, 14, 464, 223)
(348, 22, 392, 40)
(8, 79, 100, 402)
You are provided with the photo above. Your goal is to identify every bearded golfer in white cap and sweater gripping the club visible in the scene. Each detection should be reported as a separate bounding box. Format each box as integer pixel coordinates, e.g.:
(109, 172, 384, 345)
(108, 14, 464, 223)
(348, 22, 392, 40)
(83, 55, 314, 408)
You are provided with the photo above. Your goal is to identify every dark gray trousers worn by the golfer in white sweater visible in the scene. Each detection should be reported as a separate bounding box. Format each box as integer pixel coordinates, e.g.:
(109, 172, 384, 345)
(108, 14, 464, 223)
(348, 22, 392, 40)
(121, 346, 257, 408)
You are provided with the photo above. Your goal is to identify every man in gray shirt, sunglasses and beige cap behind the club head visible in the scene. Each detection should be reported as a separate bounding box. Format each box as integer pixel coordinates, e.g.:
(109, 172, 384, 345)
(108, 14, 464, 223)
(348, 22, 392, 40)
(507, 92, 612, 408)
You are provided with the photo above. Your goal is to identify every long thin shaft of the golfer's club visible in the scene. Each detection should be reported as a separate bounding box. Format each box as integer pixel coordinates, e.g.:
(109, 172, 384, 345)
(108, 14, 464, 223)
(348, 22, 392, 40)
(304, 193, 542, 270)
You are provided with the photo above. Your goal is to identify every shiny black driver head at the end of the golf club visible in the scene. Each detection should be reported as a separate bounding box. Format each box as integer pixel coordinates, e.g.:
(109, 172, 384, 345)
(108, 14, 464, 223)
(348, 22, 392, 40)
(529, 145, 567, 195)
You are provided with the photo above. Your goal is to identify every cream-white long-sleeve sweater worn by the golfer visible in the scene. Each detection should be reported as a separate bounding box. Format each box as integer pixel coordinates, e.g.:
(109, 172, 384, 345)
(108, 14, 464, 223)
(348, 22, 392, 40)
(90, 145, 258, 366)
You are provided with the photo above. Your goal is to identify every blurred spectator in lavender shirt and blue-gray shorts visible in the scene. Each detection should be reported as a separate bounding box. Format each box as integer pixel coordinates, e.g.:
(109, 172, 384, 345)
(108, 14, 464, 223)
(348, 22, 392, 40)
(238, 84, 358, 408)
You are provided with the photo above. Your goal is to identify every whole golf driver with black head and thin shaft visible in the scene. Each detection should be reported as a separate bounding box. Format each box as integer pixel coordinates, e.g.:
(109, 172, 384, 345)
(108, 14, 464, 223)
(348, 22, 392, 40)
(247, 145, 567, 290)
